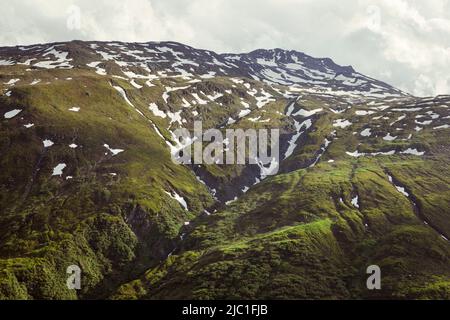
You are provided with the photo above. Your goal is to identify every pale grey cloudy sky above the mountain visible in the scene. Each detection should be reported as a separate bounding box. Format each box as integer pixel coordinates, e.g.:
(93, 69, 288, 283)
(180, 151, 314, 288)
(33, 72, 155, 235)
(0, 0, 450, 96)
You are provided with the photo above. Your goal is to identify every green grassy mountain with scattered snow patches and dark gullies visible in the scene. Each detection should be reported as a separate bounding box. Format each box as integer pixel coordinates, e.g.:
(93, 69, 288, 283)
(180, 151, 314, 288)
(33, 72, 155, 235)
(0, 41, 450, 299)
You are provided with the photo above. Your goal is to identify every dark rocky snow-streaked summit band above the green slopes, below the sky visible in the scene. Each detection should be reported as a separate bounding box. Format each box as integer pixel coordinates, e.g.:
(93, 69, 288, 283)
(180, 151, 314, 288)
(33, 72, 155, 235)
(0, 41, 405, 97)
